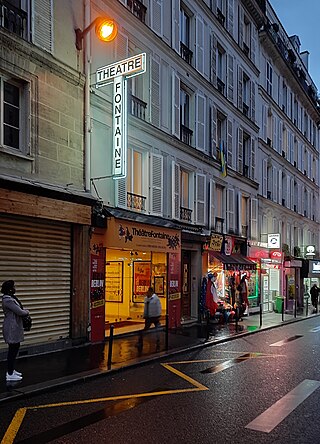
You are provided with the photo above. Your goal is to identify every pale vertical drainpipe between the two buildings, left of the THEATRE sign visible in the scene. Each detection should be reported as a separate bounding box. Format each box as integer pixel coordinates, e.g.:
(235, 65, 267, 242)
(84, 0, 91, 191)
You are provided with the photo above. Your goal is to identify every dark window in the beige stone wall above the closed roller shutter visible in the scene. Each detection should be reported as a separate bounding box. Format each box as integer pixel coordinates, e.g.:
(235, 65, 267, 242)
(0, 77, 29, 154)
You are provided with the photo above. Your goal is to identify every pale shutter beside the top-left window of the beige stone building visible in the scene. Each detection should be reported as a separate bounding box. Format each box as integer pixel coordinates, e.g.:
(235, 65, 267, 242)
(32, 0, 53, 53)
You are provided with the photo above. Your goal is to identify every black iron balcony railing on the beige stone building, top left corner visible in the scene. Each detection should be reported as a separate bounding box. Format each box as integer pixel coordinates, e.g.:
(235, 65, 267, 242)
(0, 0, 28, 39)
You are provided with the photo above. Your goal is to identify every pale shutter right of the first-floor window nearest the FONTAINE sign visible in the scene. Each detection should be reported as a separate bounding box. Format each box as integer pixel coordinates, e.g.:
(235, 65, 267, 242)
(150, 154, 163, 216)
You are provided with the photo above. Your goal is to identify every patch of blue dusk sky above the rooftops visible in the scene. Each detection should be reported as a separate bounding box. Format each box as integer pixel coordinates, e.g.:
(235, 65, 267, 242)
(269, 0, 320, 93)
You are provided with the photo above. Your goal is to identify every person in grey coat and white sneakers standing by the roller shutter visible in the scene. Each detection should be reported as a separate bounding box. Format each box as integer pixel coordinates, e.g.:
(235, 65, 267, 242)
(1, 280, 29, 381)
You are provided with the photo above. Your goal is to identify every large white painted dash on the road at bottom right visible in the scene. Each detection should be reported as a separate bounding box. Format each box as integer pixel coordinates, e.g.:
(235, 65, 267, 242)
(245, 379, 320, 433)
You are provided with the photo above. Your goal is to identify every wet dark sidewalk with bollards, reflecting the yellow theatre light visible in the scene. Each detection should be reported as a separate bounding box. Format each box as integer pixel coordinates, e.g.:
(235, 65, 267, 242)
(0, 310, 315, 403)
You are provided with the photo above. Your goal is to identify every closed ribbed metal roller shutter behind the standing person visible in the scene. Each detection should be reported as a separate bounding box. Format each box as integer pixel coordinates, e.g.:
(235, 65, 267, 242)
(0, 214, 71, 348)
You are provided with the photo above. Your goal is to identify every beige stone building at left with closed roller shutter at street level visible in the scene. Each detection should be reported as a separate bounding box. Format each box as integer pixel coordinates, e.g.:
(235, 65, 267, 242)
(0, 0, 95, 349)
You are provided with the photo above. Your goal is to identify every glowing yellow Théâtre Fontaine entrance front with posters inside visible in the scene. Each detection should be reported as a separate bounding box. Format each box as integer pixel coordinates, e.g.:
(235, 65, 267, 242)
(91, 217, 181, 329)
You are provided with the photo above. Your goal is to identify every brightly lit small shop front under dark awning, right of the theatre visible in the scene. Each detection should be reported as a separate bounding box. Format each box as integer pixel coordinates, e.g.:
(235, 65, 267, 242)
(205, 235, 259, 309)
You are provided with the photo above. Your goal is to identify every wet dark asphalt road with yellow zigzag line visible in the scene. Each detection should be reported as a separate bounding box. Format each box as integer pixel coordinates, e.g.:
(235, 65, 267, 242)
(0, 317, 320, 444)
